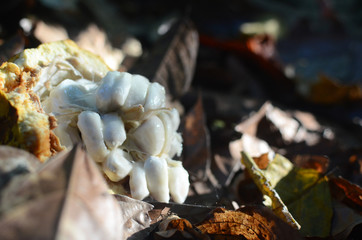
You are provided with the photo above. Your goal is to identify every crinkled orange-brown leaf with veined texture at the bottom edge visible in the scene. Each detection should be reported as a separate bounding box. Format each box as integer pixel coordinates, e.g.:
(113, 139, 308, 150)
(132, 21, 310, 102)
(196, 206, 301, 240)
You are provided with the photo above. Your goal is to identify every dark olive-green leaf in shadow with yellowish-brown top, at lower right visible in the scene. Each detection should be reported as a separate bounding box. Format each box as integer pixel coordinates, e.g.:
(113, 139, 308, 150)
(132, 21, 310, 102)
(275, 167, 333, 237)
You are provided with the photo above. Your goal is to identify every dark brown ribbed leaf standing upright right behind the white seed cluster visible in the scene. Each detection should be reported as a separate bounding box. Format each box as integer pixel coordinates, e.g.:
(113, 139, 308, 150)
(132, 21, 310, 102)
(129, 17, 199, 98)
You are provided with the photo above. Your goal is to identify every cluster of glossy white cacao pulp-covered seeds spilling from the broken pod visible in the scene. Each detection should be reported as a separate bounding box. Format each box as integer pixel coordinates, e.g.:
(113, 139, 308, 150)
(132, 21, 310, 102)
(42, 71, 190, 203)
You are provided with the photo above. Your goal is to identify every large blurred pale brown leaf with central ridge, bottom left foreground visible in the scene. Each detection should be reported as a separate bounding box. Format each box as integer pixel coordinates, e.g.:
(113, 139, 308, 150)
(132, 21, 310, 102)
(0, 146, 149, 239)
